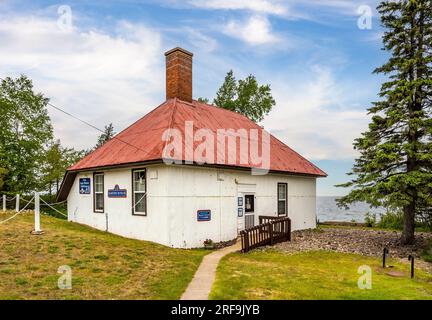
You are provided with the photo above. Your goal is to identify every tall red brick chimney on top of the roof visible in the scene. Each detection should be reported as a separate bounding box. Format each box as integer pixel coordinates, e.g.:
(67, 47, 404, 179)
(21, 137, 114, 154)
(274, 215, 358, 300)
(165, 47, 193, 102)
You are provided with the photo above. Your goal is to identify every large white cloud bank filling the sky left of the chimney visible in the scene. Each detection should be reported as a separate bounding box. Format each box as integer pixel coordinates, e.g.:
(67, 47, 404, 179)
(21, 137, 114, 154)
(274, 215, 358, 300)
(0, 16, 164, 148)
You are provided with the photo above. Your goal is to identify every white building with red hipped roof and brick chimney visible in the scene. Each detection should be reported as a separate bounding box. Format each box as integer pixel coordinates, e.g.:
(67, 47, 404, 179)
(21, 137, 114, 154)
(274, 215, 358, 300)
(58, 48, 326, 248)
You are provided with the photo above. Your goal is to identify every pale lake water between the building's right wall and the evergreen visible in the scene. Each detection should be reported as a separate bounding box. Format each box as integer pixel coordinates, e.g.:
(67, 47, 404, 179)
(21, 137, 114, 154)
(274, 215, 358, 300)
(317, 197, 385, 222)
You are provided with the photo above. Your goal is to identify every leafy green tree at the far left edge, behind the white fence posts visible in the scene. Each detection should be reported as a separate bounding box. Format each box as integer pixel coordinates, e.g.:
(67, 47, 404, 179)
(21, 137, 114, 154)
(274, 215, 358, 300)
(0, 75, 52, 193)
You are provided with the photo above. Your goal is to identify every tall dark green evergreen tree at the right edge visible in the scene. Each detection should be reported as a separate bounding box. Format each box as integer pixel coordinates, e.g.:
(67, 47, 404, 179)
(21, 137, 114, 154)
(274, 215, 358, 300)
(339, 0, 432, 244)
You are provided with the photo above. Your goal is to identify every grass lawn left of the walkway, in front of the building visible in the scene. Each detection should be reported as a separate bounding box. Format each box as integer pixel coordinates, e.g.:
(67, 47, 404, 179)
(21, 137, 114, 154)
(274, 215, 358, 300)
(0, 212, 208, 299)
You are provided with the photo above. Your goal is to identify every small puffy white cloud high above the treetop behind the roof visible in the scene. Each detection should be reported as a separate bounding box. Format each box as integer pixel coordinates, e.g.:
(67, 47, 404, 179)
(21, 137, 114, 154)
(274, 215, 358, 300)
(223, 15, 280, 45)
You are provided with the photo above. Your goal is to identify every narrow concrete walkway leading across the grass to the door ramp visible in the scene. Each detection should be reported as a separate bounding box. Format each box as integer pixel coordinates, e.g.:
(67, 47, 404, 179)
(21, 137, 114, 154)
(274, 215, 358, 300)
(180, 242, 241, 300)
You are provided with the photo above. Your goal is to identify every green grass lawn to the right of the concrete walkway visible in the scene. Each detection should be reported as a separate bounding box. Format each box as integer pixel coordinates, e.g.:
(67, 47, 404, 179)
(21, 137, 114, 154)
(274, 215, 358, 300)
(210, 249, 432, 299)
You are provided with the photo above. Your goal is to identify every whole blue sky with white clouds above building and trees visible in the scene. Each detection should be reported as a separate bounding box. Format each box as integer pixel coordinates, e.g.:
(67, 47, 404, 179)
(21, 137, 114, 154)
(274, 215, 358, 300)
(0, 0, 387, 195)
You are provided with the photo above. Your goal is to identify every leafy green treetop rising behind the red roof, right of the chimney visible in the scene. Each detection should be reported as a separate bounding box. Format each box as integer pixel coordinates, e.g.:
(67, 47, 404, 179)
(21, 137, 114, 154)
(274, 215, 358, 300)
(213, 70, 275, 122)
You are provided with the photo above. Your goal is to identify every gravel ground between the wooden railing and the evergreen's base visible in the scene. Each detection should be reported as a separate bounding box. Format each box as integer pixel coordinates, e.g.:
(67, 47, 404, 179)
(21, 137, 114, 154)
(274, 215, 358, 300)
(275, 228, 432, 270)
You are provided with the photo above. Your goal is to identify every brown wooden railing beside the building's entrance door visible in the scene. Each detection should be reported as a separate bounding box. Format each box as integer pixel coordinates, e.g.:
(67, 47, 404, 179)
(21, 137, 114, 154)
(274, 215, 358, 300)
(240, 216, 291, 253)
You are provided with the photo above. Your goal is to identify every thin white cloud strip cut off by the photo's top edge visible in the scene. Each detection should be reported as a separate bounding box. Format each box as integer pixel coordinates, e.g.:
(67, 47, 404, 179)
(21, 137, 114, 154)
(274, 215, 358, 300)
(189, 0, 287, 15)
